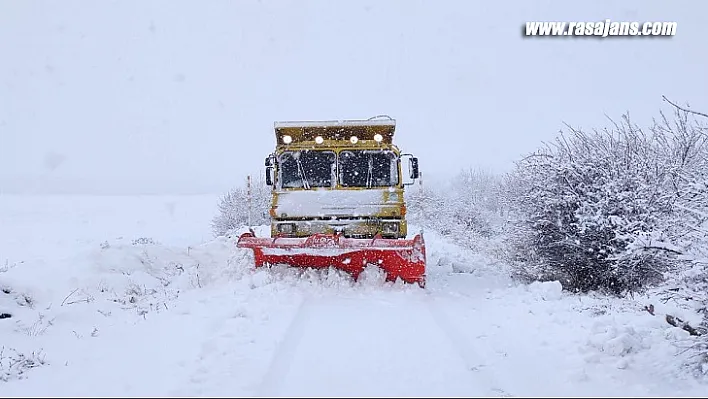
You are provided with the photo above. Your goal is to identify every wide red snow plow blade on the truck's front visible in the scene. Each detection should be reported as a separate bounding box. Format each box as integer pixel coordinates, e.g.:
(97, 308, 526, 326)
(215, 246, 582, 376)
(236, 233, 425, 287)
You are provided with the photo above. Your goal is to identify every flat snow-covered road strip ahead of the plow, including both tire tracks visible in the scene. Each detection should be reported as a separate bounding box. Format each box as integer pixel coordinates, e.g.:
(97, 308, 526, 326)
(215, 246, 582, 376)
(254, 295, 499, 397)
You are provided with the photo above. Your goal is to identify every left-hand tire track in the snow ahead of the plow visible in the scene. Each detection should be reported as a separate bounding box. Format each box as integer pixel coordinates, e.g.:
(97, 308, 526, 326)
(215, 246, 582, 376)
(255, 297, 312, 397)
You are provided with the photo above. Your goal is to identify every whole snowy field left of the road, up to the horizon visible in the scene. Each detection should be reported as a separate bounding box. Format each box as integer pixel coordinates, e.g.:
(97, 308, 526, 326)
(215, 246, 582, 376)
(0, 195, 221, 386)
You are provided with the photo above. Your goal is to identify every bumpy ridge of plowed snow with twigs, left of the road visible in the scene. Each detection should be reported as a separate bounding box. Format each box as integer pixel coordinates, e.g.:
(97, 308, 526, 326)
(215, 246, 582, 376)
(0, 239, 235, 379)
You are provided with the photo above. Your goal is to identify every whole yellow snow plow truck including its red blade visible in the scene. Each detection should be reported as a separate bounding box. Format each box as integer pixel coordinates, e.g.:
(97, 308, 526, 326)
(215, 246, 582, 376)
(237, 116, 426, 288)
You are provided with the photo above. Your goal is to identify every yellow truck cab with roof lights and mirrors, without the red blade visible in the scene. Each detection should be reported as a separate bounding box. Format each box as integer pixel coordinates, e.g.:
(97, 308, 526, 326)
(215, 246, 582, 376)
(265, 117, 419, 239)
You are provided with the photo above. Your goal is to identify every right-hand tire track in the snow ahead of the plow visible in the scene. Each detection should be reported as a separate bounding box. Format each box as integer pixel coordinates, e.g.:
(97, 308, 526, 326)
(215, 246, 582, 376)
(425, 294, 513, 397)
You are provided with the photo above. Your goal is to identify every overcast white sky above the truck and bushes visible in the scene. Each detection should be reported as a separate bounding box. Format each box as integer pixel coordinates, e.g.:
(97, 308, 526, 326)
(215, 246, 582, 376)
(0, 0, 708, 193)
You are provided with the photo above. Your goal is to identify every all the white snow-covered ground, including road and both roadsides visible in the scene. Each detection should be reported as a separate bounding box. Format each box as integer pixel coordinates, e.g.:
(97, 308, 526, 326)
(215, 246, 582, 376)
(0, 196, 708, 396)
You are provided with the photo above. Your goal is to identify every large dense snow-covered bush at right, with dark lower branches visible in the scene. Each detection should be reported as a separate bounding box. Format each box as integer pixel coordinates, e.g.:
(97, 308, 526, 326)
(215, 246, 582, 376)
(504, 104, 706, 294)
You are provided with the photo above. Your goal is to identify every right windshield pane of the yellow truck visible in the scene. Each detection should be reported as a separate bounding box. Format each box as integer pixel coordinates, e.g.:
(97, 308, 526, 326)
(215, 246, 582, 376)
(339, 150, 398, 187)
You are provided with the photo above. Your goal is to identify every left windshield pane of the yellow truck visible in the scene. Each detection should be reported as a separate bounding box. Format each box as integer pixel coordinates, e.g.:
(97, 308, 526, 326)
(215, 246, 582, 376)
(279, 150, 336, 189)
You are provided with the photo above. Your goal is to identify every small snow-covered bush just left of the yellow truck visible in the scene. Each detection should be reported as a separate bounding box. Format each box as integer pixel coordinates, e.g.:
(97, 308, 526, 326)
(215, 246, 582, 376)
(211, 177, 271, 237)
